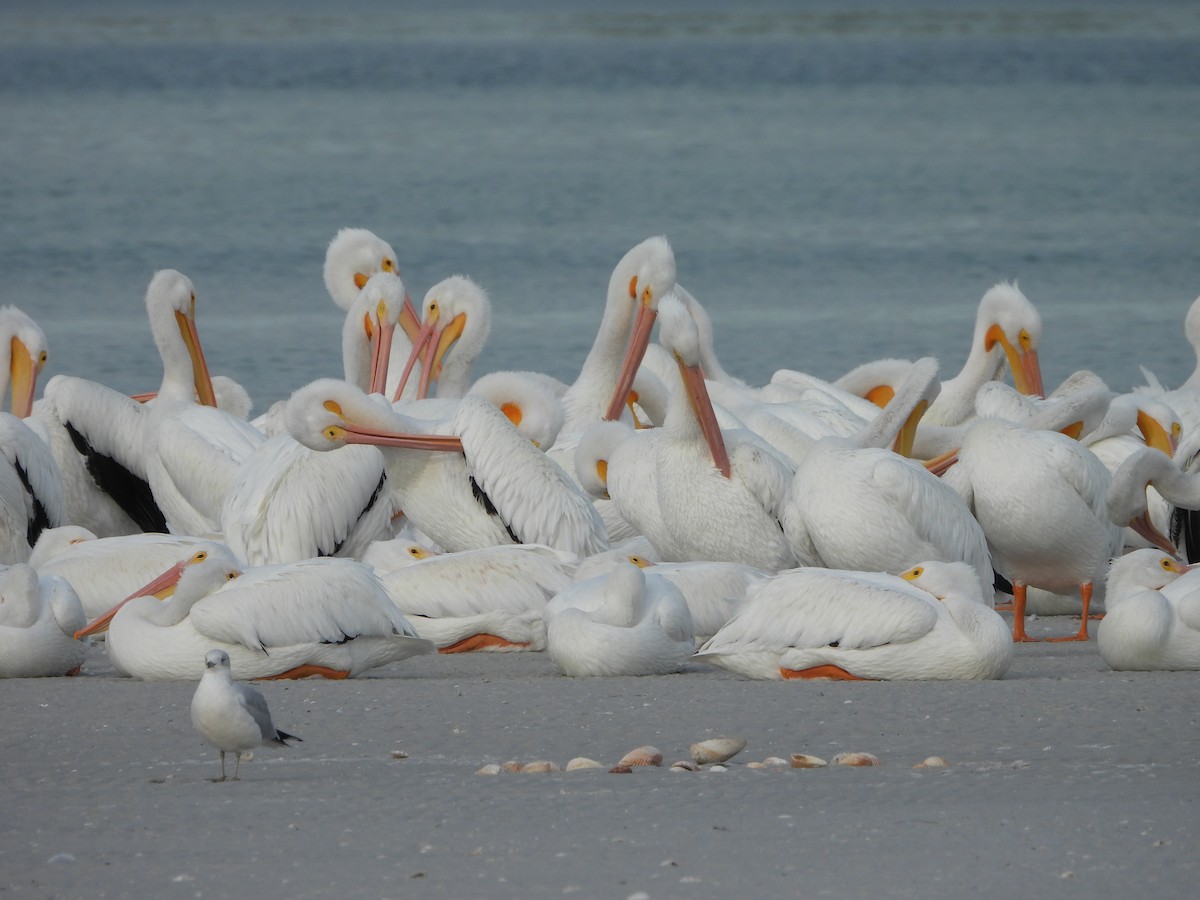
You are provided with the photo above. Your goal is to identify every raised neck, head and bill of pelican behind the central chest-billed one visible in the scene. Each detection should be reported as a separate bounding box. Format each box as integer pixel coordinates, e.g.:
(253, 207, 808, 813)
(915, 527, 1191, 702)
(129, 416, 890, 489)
(563, 238, 676, 434)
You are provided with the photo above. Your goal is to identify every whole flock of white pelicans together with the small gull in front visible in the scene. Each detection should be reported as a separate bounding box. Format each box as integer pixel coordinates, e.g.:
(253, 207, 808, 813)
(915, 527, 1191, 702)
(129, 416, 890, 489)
(0, 229, 1200, 715)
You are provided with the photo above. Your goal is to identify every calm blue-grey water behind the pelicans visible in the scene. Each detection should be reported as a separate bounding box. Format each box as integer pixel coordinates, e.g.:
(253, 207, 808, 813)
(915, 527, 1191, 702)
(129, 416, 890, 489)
(0, 0, 1200, 409)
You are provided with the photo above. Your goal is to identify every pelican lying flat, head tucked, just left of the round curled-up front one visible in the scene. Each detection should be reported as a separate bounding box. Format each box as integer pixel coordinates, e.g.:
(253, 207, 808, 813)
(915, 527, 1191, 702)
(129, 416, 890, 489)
(362, 540, 578, 653)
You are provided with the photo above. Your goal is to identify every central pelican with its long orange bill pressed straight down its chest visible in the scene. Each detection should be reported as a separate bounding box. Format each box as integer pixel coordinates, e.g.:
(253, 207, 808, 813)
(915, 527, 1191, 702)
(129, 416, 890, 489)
(638, 295, 794, 571)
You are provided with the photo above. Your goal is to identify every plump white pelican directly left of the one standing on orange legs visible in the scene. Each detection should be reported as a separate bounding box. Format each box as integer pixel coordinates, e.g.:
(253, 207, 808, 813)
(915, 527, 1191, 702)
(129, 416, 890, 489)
(780, 359, 994, 606)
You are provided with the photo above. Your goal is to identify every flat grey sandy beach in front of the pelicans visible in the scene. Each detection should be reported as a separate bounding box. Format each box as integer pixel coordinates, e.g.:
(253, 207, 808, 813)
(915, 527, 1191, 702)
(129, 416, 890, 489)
(0, 618, 1200, 900)
